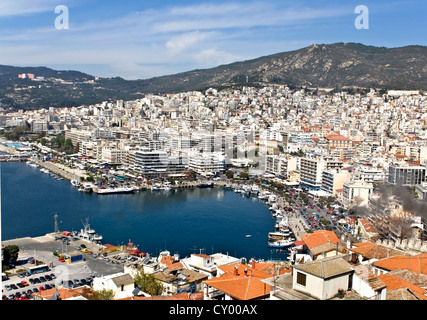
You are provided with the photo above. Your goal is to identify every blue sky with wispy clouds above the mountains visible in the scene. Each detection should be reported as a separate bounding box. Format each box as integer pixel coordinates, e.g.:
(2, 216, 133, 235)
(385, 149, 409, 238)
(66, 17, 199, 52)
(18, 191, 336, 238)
(0, 0, 427, 79)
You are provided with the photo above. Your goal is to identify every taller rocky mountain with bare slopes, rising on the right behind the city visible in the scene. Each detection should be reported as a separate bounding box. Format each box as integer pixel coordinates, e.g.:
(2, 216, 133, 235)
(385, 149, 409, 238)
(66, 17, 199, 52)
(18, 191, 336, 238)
(136, 43, 427, 92)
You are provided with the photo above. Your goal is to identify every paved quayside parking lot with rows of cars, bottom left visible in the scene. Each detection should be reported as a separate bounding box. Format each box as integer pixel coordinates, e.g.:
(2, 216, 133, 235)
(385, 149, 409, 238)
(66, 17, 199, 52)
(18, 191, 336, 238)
(2, 234, 126, 300)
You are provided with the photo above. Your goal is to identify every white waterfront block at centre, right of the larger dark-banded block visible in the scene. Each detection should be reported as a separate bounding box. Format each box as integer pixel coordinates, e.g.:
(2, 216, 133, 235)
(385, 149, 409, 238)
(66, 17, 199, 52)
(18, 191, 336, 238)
(188, 152, 226, 174)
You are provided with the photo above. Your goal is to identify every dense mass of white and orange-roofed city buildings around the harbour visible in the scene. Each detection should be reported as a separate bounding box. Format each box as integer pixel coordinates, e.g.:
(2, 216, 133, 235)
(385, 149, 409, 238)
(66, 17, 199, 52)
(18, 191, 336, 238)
(0, 86, 427, 300)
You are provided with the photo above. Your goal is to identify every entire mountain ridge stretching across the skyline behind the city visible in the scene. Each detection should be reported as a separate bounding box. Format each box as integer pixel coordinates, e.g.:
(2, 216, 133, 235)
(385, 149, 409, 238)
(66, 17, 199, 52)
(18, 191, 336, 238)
(0, 43, 427, 108)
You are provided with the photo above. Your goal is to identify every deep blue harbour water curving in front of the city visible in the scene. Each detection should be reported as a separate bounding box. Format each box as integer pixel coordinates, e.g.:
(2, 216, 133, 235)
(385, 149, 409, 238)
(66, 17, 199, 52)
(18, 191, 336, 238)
(1, 162, 286, 260)
